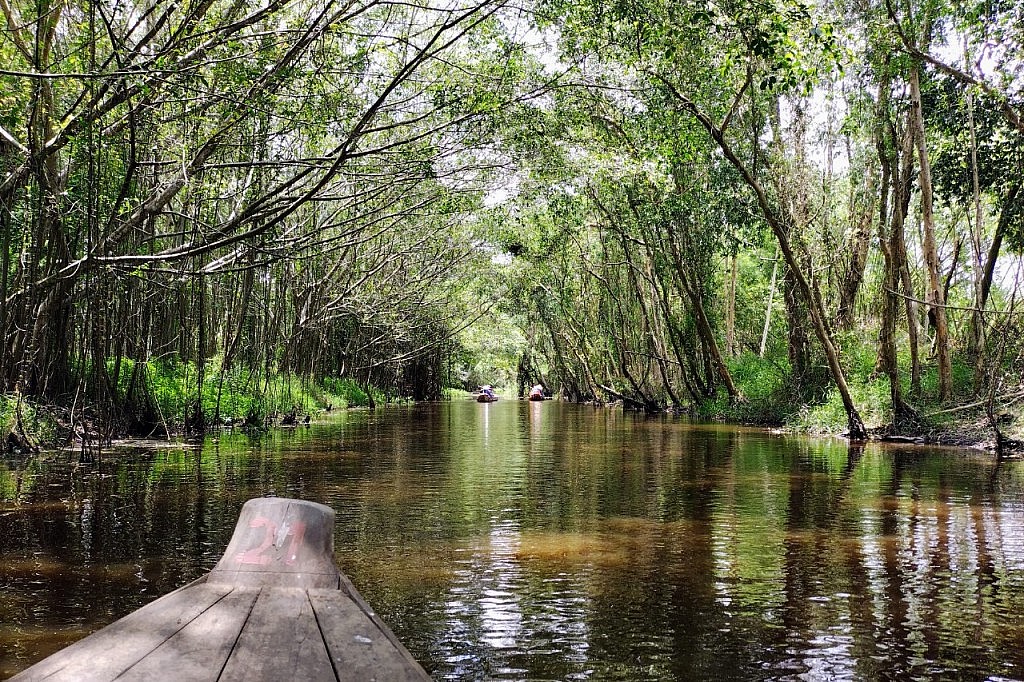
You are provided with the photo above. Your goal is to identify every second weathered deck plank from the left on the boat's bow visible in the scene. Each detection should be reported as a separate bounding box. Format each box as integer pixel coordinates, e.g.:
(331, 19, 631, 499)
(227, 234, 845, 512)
(118, 588, 262, 682)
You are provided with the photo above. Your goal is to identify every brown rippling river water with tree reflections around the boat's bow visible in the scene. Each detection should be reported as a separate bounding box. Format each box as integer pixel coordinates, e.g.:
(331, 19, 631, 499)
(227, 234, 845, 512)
(0, 400, 1024, 680)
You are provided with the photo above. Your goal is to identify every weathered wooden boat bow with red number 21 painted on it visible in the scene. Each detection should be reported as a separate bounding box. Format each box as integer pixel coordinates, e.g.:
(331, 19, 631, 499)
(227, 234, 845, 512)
(11, 498, 430, 682)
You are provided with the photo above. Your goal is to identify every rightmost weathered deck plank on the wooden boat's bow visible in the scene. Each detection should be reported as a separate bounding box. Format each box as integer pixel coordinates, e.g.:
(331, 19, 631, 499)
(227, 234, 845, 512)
(309, 590, 430, 682)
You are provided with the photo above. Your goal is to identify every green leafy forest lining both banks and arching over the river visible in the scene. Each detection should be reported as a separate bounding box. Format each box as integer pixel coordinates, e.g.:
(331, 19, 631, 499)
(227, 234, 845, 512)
(0, 0, 1024, 450)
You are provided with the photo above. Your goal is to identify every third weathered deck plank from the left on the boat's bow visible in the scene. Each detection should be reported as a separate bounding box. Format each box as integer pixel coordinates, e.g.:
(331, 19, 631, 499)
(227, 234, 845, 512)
(220, 588, 336, 682)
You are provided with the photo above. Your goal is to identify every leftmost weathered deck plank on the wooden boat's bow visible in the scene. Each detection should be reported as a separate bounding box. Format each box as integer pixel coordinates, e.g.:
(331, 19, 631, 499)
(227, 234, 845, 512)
(11, 583, 232, 682)
